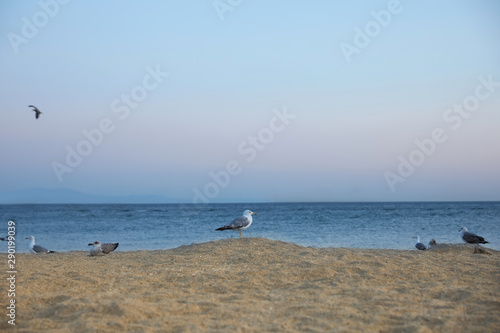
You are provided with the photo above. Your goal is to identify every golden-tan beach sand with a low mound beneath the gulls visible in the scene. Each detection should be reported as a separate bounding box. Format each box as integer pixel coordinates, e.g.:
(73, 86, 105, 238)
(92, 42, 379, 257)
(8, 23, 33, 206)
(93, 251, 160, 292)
(0, 238, 500, 333)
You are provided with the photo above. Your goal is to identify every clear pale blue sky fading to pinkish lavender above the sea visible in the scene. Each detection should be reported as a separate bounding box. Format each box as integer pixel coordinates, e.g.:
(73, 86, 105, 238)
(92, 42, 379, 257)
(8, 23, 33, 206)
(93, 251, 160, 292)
(0, 0, 500, 203)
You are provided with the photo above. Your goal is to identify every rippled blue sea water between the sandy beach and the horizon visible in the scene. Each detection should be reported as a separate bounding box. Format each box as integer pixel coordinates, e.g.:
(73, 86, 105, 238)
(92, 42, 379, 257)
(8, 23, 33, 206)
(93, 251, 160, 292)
(0, 202, 500, 252)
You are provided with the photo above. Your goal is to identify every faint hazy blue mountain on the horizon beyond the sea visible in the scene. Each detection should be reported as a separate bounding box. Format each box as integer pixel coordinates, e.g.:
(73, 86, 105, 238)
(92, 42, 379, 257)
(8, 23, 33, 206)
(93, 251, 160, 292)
(0, 188, 177, 204)
